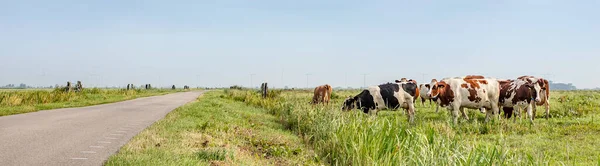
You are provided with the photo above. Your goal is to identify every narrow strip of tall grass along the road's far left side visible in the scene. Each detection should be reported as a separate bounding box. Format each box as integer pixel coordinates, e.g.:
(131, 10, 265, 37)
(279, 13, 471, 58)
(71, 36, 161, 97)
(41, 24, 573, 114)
(0, 88, 182, 116)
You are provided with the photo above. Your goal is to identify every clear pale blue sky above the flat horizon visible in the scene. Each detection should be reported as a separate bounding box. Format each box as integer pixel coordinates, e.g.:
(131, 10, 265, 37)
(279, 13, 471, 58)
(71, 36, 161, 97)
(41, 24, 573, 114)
(0, 0, 600, 88)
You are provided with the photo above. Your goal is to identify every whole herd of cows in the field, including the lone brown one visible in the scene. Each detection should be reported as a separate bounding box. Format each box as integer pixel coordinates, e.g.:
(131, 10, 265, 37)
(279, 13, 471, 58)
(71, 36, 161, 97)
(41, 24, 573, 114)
(313, 75, 550, 123)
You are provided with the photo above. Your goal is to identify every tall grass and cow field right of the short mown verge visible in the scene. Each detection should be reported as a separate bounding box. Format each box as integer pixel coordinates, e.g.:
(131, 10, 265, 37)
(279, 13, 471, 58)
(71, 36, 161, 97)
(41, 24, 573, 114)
(225, 90, 600, 165)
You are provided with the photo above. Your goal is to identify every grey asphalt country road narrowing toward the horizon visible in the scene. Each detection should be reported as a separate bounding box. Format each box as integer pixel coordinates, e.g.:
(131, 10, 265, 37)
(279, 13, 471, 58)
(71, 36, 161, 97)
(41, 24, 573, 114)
(0, 91, 203, 166)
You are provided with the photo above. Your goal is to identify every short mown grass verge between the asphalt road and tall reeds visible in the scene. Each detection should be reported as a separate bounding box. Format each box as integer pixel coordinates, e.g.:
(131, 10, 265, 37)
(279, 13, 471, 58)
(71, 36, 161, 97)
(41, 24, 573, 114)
(106, 91, 319, 165)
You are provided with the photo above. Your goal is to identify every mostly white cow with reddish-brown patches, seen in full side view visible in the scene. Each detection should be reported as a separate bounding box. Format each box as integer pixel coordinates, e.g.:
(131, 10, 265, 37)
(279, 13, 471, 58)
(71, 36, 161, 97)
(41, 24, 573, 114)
(427, 76, 500, 123)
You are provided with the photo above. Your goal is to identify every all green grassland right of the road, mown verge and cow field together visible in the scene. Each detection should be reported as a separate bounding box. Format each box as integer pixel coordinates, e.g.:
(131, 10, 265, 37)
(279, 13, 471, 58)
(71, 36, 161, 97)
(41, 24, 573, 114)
(108, 90, 600, 165)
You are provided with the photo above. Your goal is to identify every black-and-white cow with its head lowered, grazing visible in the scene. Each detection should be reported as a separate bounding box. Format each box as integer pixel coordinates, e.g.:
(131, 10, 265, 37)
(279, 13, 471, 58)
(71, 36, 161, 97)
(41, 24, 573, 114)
(342, 82, 417, 123)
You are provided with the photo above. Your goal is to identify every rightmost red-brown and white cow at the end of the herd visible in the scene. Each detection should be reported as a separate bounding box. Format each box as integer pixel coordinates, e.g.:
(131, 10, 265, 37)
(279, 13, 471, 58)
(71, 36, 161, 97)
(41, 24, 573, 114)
(498, 79, 541, 124)
